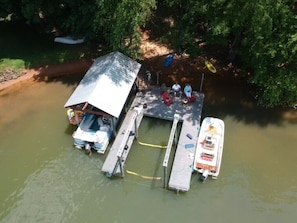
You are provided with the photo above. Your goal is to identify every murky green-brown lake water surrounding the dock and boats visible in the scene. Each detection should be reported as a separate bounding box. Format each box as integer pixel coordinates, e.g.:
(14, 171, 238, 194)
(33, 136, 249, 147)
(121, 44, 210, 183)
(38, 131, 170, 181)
(0, 78, 297, 223)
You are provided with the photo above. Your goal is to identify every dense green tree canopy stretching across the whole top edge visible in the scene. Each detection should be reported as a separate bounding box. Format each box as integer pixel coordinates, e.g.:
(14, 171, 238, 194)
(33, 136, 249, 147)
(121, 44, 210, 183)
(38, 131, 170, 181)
(0, 0, 297, 107)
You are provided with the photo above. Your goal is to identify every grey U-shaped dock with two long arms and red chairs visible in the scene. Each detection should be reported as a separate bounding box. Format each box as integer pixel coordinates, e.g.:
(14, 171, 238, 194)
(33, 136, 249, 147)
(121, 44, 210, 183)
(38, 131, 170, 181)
(102, 87, 204, 191)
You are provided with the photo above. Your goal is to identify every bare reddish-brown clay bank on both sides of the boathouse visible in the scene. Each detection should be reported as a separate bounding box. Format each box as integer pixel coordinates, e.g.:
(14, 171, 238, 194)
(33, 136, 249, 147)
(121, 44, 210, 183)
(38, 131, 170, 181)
(0, 32, 238, 90)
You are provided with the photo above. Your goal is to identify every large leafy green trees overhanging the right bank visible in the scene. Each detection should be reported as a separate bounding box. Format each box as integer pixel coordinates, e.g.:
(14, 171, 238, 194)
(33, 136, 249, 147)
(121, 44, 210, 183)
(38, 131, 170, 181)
(162, 0, 297, 107)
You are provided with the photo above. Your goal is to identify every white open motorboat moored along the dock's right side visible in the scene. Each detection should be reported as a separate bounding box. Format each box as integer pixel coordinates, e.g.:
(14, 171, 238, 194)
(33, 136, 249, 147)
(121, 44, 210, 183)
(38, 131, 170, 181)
(194, 117, 225, 182)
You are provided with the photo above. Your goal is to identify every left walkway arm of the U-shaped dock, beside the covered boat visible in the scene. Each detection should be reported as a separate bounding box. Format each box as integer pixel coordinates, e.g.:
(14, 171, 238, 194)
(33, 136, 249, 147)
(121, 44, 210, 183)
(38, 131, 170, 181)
(101, 107, 143, 177)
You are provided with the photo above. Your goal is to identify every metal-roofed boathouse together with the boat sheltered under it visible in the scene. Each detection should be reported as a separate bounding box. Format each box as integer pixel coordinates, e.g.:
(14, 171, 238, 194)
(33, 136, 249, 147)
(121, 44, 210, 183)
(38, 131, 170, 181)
(64, 52, 141, 154)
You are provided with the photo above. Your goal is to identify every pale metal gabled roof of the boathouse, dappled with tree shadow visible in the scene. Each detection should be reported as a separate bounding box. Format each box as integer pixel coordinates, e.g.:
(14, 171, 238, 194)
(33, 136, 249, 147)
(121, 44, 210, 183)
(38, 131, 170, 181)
(64, 52, 141, 118)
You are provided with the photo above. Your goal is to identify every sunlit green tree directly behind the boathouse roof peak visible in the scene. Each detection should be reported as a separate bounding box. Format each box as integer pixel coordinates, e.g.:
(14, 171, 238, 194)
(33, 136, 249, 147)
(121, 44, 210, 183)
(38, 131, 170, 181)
(93, 0, 156, 59)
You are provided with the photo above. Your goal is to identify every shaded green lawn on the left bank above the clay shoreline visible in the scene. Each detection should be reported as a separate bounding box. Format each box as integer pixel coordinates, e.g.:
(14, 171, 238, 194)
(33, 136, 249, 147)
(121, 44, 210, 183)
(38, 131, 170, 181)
(0, 20, 91, 75)
